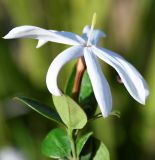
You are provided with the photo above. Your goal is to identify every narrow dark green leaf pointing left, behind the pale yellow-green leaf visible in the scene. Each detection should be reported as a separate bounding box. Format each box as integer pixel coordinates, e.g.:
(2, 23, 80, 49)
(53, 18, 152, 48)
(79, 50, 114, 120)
(14, 97, 64, 125)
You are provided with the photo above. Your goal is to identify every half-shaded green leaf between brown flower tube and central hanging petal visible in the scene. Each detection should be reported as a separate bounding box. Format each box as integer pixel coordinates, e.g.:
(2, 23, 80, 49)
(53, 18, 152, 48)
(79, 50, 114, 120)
(79, 71, 97, 118)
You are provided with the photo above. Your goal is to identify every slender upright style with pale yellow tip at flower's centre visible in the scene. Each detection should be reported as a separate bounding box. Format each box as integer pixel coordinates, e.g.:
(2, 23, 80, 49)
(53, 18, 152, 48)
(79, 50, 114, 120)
(86, 13, 96, 47)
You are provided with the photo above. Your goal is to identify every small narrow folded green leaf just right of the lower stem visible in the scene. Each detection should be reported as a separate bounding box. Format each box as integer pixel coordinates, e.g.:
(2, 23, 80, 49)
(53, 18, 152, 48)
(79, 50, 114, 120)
(76, 132, 93, 156)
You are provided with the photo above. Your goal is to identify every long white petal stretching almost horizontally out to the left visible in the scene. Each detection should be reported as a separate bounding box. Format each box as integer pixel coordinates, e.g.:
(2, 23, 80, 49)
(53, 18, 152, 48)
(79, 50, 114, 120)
(3, 26, 85, 46)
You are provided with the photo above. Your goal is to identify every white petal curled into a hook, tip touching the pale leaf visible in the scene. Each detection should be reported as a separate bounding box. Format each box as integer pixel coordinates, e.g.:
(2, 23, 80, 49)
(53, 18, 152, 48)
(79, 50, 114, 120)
(46, 45, 83, 96)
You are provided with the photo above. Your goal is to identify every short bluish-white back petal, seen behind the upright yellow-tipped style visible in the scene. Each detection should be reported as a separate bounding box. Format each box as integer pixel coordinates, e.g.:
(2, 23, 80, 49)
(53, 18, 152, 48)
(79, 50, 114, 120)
(82, 25, 106, 45)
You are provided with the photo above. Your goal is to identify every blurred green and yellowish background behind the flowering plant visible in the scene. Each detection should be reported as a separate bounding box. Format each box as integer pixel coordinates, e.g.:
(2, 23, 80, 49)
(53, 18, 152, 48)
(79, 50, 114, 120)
(0, 0, 155, 160)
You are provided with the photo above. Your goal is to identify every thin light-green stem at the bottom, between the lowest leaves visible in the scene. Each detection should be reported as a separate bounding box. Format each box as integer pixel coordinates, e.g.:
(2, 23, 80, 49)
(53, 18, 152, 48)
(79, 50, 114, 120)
(68, 129, 78, 160)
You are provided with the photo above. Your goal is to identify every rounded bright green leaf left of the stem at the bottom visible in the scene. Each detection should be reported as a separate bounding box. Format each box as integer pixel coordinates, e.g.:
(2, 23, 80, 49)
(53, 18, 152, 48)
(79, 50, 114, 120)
(42, 128, 71, 158)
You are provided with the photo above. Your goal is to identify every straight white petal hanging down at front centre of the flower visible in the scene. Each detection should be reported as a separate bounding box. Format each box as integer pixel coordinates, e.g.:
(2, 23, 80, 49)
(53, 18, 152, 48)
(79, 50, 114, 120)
(84, 48, 112, 117)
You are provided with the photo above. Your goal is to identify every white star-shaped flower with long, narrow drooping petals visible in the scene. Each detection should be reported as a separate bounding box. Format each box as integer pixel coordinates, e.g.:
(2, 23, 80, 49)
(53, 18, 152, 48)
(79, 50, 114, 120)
(4, 18, 149, 117)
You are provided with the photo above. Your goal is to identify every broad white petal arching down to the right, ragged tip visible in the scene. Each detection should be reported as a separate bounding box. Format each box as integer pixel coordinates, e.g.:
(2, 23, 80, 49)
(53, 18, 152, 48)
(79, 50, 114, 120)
(92, 46, 149, 104)
